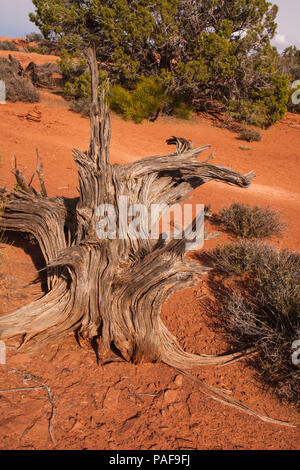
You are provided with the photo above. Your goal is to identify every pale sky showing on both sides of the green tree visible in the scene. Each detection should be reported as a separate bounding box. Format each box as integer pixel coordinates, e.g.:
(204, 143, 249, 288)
(0, 0, 300, 51)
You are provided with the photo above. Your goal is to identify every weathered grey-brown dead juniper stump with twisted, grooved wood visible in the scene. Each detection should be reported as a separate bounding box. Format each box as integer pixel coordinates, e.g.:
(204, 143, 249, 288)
(0, 2, 294, 424)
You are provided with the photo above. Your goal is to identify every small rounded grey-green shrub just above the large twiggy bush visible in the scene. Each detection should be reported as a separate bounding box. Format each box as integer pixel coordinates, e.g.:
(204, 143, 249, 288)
(216, 203, 284, 238)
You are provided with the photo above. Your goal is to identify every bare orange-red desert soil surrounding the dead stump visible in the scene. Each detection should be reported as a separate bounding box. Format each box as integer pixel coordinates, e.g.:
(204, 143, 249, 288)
(0, 51, 300, 450)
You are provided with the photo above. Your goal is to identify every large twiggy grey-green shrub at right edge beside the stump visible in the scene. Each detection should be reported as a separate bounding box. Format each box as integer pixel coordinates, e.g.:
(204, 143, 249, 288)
(207, 241, 300, 407)
